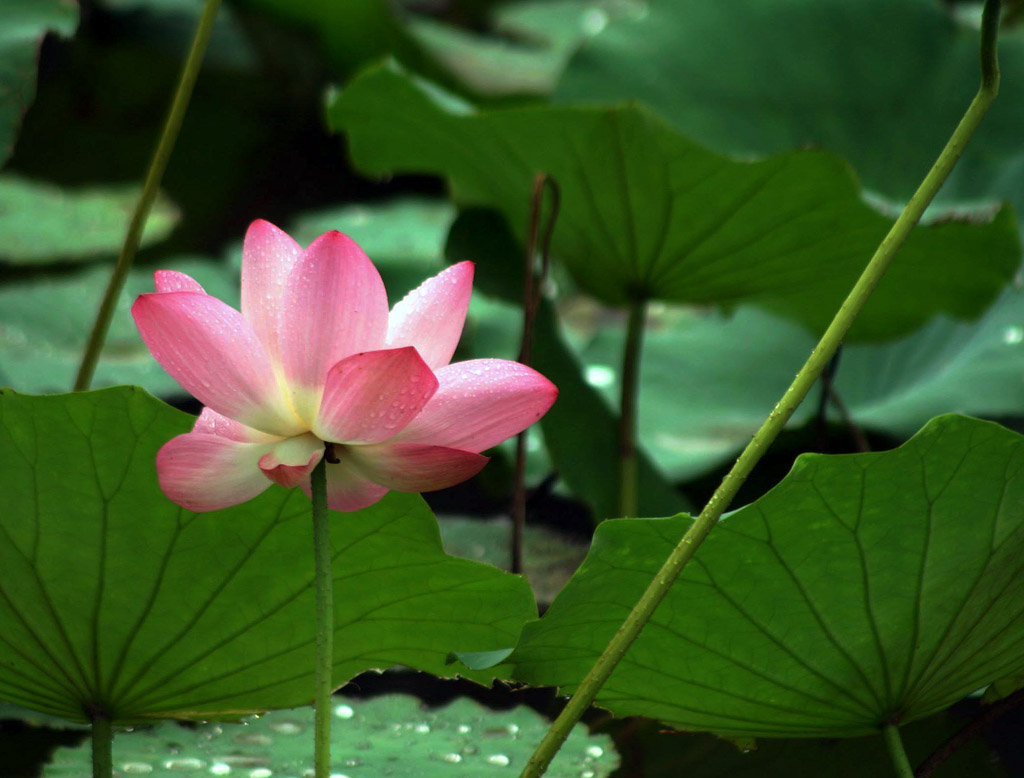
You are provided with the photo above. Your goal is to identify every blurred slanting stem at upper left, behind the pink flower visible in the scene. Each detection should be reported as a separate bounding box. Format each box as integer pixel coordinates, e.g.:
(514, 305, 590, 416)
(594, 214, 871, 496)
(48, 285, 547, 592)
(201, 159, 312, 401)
(75, 0, 220, 392)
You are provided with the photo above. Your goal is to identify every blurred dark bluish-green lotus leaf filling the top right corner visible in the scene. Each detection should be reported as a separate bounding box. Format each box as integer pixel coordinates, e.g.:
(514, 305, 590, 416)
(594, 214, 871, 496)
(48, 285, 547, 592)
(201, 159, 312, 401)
(556, 0, 1024, 212)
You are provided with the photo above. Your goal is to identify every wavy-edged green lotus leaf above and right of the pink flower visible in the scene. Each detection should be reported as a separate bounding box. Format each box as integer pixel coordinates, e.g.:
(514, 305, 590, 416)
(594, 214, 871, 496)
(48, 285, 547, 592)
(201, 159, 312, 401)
(329, 66, 1019, 339)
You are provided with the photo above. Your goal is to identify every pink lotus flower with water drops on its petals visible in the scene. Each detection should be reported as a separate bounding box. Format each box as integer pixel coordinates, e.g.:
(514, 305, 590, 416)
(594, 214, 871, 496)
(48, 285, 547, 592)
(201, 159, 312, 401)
(132, 221, 558, 511)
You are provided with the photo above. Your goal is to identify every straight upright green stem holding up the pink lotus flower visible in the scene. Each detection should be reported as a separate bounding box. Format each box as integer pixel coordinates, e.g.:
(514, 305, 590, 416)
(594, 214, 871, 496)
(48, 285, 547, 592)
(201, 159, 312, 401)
(310, 456, 334, 778)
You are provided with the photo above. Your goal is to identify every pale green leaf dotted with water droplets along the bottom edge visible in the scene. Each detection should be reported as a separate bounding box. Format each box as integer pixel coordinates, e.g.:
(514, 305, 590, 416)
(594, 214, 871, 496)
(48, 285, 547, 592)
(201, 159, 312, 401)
(43, 694, 618, 778)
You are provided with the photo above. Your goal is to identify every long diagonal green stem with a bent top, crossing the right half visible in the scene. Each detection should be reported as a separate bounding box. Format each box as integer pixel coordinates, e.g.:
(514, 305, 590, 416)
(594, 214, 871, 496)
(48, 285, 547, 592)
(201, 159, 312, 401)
(520, 0, 999, 778)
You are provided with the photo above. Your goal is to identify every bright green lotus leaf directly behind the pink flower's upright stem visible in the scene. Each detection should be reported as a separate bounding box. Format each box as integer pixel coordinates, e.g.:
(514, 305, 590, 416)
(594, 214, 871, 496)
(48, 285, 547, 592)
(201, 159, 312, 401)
(0, 387, 536, 722)
